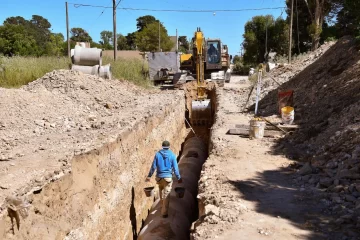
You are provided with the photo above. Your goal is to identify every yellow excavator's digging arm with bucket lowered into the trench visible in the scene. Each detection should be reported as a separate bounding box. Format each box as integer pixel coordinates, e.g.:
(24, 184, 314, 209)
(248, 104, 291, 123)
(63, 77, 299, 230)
(190, 28, 212, 125)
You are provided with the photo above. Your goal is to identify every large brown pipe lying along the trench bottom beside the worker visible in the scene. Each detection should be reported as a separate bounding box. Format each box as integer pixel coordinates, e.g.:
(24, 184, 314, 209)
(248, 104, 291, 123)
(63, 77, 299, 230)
(138, 137, 207, 240)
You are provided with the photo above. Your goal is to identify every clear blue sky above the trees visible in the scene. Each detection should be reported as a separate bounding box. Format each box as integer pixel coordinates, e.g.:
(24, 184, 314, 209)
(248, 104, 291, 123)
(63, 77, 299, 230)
(0, 0, 286, 55)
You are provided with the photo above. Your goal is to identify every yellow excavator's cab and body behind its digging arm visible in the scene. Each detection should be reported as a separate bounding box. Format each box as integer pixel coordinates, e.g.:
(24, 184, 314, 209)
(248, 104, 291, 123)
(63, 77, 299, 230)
(178, 28, 231, 86)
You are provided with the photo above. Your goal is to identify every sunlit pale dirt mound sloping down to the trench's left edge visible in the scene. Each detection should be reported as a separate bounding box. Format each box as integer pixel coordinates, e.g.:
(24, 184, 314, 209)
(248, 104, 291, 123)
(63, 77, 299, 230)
(0, 70, 183, 212)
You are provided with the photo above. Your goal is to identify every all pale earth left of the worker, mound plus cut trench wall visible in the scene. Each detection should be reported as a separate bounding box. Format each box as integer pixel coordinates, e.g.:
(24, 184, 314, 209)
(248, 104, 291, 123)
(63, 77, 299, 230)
(0, 70, 186, 239)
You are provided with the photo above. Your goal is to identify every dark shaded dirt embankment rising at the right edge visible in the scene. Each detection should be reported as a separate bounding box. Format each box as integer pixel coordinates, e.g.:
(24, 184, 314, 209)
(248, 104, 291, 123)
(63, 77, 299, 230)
(259, 37, 360, 230)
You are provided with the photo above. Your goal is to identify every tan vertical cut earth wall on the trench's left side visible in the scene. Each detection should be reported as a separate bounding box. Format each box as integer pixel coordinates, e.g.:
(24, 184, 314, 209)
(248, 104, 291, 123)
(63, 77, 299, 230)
(0, 92, 186, 240)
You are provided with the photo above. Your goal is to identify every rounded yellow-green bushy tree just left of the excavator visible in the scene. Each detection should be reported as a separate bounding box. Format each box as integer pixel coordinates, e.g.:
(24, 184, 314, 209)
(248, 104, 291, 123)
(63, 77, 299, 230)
(135, 23, 174, 51)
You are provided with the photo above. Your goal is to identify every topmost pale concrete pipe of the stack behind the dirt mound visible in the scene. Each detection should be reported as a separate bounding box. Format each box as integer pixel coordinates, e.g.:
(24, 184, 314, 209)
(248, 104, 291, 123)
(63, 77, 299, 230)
(72, 47, 102, 66)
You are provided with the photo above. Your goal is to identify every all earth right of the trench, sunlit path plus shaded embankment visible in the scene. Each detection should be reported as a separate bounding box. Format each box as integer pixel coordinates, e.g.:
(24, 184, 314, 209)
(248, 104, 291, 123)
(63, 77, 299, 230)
(192, 37, 360, 240)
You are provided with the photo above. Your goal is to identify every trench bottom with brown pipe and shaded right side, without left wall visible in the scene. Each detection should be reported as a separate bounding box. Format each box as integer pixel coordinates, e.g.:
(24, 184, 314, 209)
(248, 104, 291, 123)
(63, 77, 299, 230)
(137, 84, 217, 240)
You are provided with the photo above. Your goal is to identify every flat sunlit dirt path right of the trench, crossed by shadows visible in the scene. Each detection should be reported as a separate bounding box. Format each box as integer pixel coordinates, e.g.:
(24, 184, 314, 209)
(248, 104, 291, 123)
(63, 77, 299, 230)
(193, 77, 356, 240)
